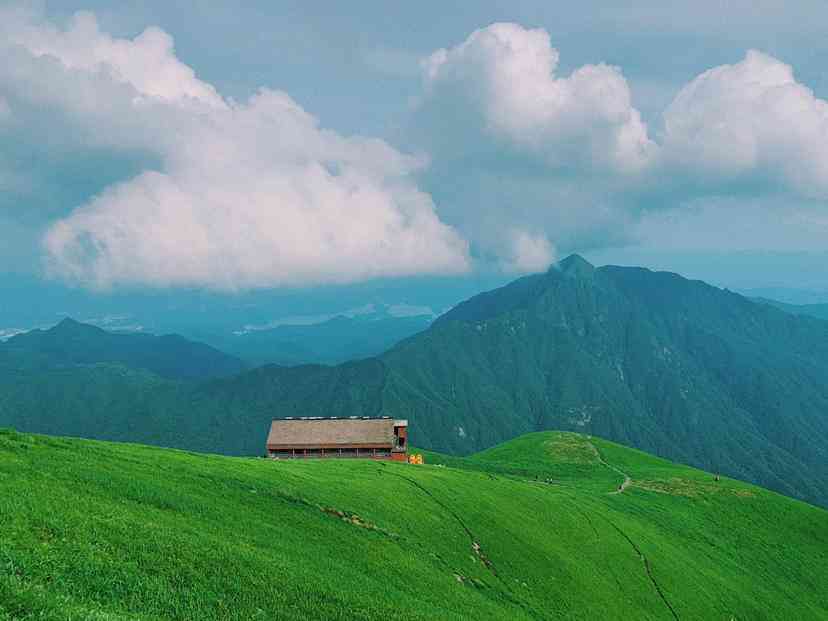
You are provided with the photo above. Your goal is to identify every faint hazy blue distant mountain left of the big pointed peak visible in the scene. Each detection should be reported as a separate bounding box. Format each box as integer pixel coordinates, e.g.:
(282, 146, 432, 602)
(199, 313, 432, 366)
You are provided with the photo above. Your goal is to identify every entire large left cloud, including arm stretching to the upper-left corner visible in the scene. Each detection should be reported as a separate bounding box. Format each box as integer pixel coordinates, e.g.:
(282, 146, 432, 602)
(0, 10, 468, 289)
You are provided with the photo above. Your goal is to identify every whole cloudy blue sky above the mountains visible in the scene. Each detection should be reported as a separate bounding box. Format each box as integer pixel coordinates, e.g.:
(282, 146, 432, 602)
(0, 0, 828, 324)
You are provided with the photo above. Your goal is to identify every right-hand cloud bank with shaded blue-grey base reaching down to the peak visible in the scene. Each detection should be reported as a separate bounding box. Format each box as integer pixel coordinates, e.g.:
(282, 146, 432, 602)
(412, 24, 828, 264)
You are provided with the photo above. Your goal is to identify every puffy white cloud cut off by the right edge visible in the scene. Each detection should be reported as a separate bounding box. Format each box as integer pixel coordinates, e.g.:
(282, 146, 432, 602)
(664, 50, 828, 197)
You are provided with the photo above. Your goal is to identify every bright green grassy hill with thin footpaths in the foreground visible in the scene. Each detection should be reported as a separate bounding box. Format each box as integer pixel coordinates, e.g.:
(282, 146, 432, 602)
(0, 431, 828, 621)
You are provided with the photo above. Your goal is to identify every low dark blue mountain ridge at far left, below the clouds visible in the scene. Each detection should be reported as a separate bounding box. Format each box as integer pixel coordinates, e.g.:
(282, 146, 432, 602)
(0, 319, 246, 380)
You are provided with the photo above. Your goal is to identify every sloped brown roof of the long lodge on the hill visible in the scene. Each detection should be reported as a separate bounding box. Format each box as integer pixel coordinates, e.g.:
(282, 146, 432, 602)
(267, 418, 394, 448)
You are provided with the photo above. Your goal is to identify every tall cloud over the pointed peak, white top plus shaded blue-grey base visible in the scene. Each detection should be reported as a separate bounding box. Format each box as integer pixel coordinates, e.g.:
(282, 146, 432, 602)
(411, 23, 658, 272)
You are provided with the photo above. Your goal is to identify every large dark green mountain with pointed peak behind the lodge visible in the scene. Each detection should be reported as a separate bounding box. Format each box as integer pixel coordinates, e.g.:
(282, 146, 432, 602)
(204, 256, 828, 504)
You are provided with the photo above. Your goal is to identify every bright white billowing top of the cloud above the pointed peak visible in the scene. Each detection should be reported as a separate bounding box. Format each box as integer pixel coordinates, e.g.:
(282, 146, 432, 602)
(422, 23, 655, 172)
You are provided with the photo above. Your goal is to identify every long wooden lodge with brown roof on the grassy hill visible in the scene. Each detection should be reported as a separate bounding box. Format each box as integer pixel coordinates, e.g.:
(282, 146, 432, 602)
(267, 416, 408, 461)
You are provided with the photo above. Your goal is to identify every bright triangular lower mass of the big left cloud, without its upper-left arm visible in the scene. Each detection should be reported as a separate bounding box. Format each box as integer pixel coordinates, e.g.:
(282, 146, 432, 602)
(46, 91, 467, 289)
